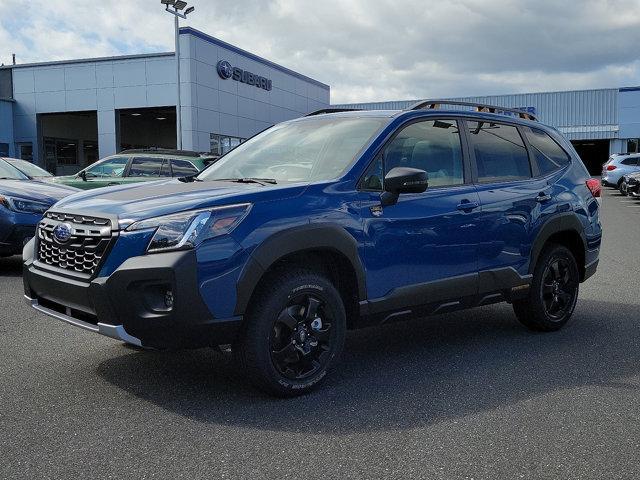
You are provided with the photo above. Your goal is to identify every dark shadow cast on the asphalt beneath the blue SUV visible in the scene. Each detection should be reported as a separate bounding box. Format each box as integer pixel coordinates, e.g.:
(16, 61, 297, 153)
(98, 299, 640, 433)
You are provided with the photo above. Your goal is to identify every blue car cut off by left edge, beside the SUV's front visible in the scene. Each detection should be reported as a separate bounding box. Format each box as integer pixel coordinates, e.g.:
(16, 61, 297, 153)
(0, 159, 78, 257)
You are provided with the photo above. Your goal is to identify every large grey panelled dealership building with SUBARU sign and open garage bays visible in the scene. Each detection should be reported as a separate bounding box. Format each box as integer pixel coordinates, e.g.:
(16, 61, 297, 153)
(0, 27, 329, 175)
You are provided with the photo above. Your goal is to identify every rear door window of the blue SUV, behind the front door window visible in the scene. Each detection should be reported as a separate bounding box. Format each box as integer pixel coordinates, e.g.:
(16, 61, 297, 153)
(467, 121, 531, 183)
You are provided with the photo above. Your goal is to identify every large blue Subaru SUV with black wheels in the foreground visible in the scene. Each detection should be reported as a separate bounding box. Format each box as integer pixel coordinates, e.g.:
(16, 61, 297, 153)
(24, 101, 602, 396)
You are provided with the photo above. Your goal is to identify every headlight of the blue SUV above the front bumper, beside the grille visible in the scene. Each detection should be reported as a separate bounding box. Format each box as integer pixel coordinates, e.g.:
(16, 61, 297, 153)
(125, 203, 251, 252)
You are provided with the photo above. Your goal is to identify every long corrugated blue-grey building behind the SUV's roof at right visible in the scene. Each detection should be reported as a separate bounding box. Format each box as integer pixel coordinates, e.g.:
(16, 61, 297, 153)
(335, 87, 640, 174)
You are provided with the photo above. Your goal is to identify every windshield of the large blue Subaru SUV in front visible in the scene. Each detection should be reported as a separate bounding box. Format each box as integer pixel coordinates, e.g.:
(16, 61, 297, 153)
(198, 117, 385, 183)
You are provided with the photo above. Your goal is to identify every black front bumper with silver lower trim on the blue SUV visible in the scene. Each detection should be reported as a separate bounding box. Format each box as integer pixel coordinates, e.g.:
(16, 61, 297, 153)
(23, 242, 242, 349)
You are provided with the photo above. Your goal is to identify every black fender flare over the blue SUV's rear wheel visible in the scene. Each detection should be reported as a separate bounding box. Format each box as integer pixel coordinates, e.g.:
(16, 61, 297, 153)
(529, 213, 587, 281)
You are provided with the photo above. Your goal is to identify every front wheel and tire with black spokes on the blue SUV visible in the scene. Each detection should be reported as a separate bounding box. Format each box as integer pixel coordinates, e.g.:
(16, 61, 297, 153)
(234, 269, 346, 397)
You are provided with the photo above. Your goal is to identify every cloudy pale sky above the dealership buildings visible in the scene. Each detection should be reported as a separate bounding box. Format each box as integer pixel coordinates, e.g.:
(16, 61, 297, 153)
(0, 0, 640, 103)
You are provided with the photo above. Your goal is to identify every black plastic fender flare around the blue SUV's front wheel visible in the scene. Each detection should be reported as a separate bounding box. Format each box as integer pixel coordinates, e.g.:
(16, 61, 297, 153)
(235, 224, 367, 315)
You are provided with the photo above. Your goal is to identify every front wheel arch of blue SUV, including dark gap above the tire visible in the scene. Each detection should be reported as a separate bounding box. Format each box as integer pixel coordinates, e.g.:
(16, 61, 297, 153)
(235, 224, 366, 315)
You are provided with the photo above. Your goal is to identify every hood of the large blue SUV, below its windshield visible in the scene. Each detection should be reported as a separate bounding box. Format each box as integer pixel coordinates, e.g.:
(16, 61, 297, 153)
(54, 179, 306, 227)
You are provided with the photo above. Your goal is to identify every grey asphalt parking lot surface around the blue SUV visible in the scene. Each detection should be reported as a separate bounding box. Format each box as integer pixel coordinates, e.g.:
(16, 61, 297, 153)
(0, 190, 640, 479)
